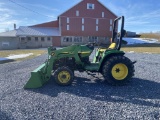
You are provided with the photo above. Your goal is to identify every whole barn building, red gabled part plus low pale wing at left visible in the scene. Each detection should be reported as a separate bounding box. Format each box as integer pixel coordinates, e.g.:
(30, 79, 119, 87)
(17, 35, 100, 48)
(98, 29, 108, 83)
(0, 0, 117, 49)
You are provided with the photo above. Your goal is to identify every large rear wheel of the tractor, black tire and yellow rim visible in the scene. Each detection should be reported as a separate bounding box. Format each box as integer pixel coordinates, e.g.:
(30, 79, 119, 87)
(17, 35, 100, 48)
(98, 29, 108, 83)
(102, 56, 135, 86)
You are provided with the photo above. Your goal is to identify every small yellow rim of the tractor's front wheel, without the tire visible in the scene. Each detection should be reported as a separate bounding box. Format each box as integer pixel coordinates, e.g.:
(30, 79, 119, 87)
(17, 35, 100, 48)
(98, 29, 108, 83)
(58, 71, 71, 83)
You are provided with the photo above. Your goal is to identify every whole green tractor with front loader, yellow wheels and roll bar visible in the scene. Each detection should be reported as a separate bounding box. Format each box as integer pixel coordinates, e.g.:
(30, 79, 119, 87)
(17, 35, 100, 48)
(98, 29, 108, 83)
(24, 16, 135, 88)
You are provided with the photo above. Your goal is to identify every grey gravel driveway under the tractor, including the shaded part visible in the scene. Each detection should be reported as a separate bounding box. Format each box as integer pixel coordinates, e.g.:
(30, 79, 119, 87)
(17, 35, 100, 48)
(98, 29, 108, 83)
(0, 53, 160, 120)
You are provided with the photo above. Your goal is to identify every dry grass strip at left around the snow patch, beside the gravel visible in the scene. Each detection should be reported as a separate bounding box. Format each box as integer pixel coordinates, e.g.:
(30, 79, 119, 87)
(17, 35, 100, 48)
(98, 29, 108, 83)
(0, 49, 47, 61)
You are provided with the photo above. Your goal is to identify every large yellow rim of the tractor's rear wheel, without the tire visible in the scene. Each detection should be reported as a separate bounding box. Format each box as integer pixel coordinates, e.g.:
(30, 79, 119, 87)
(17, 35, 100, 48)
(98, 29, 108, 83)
(112, 63, 128, 80)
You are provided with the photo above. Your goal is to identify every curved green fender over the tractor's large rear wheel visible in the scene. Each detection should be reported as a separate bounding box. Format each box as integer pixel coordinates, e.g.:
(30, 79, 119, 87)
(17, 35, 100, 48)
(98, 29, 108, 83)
(98, 51, 125, 73)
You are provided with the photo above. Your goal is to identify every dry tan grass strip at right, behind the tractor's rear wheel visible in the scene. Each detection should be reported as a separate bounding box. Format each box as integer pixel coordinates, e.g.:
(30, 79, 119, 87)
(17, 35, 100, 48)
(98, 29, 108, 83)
(121, 44, 160, 54)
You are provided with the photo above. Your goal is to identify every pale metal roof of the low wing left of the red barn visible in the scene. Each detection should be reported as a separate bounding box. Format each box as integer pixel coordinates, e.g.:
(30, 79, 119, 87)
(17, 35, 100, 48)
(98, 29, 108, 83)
(16, 26, 60, 36)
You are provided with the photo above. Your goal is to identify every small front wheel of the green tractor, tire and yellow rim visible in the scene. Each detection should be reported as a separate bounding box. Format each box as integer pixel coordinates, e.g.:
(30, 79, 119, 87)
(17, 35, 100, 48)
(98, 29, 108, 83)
(54, 67, 74, 86)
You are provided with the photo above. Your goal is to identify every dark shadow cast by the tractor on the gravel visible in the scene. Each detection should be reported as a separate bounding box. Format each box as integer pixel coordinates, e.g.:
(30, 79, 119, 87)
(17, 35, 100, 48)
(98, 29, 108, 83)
(29, 77, 160, 107)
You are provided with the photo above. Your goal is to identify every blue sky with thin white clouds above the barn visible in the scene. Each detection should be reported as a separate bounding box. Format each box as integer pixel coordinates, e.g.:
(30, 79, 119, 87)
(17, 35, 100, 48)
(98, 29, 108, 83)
(0, 0, 160, 33)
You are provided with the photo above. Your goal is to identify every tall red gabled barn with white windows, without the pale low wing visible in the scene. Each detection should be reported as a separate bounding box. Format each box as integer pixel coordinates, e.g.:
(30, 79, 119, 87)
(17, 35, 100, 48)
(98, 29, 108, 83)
(32, 0, 117, 46)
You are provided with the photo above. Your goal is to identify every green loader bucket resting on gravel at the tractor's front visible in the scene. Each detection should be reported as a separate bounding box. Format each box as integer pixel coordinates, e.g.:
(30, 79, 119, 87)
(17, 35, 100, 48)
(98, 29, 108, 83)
(24, 63, 50, 88)
